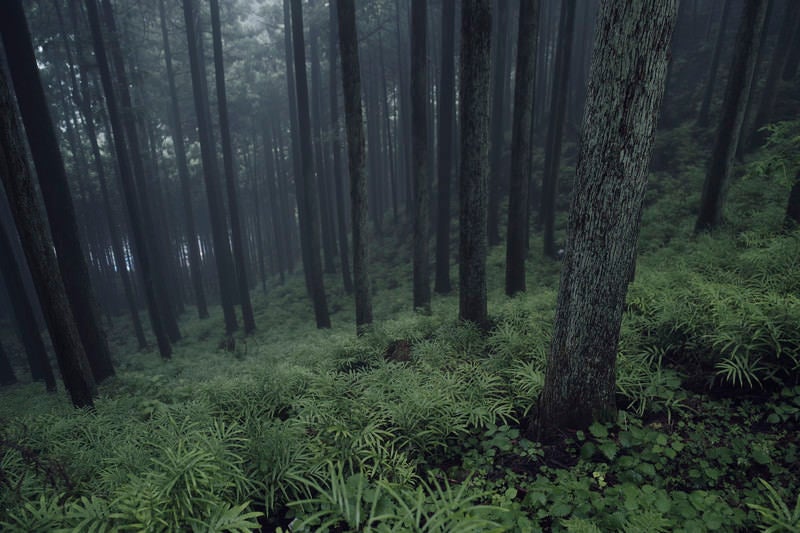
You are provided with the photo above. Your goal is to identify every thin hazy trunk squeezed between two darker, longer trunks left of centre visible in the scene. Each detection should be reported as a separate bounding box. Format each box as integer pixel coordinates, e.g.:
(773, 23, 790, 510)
(328, 2, 353, 294)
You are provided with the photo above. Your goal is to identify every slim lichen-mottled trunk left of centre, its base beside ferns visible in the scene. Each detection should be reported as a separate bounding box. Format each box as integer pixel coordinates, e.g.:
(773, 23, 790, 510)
(338, 0, 372, 333)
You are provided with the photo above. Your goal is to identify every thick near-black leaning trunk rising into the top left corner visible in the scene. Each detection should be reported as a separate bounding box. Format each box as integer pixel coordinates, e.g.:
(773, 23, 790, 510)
(0, 0, 114, 382)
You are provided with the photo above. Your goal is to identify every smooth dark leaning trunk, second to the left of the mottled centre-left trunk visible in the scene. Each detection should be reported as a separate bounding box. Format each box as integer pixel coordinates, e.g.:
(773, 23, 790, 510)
(291, 0, 331, 328)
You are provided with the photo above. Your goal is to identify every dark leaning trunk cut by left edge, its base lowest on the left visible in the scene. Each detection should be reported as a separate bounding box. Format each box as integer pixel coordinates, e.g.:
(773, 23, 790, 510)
(0, 59, 97, 407)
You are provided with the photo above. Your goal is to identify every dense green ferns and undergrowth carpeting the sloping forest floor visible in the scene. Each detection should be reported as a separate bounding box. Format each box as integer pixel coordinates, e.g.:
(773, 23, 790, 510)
(0, 124, 800, 532)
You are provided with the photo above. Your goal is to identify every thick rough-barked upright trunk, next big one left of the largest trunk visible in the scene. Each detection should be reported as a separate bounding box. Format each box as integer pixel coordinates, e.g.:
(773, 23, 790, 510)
(458, 0, 492, 328)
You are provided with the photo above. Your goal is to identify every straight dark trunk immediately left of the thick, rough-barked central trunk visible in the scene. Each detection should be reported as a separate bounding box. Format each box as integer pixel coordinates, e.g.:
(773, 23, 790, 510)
(434, 0, 456, 294)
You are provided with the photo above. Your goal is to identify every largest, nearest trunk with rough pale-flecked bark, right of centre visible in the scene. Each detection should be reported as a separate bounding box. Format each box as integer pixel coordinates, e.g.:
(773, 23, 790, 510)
(538, 0, 678, 436)
